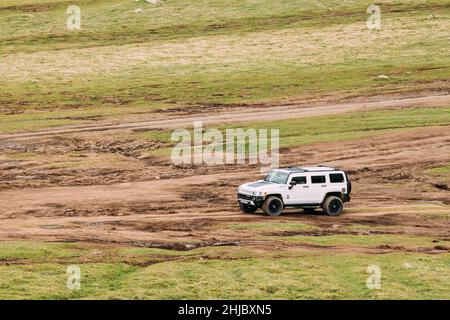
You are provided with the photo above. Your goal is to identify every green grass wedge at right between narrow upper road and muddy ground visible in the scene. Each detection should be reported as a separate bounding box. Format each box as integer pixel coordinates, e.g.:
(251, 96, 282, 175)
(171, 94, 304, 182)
(142, 108, 450, 155)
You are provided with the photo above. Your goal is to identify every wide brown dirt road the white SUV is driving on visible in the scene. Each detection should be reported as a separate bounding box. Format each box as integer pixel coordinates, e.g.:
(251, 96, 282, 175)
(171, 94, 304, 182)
(0, 127, 450, 252)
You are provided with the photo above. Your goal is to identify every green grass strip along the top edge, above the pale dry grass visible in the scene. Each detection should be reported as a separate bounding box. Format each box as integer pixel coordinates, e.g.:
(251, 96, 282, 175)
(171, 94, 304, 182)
(0, 0, 446, 52)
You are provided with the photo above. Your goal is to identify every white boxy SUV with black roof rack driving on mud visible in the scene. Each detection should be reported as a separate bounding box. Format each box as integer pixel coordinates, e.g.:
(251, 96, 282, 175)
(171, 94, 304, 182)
(238, 166, 352, 216)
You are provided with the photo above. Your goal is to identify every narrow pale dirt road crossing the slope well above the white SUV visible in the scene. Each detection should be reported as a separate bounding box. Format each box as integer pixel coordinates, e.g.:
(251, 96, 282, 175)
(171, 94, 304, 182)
(0, 95, 450, 141)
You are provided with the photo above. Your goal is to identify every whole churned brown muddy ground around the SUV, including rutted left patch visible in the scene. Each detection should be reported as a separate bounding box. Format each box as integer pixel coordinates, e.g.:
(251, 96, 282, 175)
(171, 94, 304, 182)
(0, 96, 450, 253)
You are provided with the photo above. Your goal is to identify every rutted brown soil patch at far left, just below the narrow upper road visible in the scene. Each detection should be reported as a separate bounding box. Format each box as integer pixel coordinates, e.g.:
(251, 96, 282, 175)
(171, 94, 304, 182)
(0, 136, 175, 190)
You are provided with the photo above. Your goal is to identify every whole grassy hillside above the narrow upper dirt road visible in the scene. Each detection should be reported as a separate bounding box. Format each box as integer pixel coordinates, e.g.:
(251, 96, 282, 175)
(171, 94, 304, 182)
(0, 0, 450, 130)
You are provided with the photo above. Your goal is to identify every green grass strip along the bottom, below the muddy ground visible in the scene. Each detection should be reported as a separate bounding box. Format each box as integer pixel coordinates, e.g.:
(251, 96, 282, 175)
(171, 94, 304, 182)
(0, 242, 450, 299)
